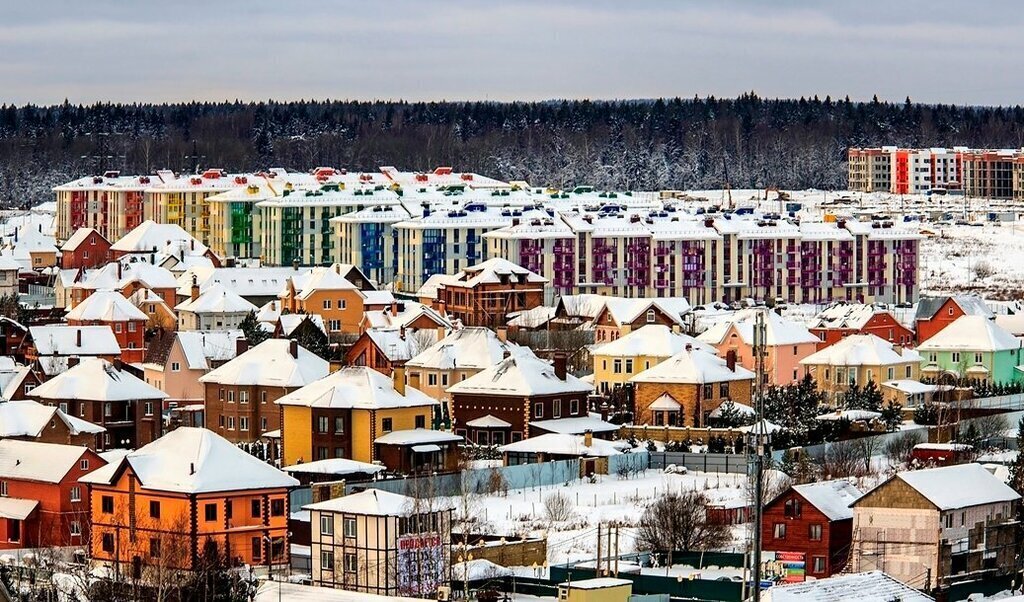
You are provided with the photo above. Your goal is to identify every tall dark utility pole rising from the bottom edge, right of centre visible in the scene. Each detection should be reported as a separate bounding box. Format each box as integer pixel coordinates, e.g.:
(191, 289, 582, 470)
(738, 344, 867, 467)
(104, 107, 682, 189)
(744, 308, 769, 602)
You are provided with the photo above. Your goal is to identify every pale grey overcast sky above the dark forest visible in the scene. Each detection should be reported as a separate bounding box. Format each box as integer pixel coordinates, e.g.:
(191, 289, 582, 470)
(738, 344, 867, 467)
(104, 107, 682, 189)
(0, 0, 1024, 104)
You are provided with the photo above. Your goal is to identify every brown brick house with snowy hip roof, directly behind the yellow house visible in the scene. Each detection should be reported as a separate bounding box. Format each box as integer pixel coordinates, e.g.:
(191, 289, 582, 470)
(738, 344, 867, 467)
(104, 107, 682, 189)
(199, 339, 330, 443)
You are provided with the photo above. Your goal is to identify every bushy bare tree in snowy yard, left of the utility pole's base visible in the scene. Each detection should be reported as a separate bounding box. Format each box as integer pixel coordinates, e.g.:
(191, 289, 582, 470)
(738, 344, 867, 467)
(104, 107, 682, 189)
(636, 491, 731, 552)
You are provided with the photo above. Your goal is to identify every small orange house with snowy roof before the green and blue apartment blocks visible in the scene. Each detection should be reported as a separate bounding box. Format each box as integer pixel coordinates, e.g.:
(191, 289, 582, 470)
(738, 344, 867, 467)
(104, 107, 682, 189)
(279, 263, 394, 337)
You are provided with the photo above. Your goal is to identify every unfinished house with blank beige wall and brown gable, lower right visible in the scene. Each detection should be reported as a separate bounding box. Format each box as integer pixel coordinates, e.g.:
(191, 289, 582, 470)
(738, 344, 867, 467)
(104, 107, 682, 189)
(851, 464, 1020, 589)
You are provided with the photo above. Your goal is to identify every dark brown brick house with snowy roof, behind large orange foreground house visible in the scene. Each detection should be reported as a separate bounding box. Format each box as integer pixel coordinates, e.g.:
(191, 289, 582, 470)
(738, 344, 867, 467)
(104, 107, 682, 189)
(29, 357, 167, 449)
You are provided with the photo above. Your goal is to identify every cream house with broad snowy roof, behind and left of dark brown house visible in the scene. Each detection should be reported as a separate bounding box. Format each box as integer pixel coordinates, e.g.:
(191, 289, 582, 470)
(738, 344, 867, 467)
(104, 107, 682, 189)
(406, 327, 517, 402)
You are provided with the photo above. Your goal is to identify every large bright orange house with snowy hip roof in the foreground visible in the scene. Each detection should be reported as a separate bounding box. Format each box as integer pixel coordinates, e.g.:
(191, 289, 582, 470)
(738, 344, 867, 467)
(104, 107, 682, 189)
(82, 427, 299, 578)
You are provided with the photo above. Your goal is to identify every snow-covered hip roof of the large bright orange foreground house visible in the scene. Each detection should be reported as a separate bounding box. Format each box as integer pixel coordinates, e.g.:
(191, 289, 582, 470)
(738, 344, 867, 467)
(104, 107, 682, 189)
(81, 427, 299, 493)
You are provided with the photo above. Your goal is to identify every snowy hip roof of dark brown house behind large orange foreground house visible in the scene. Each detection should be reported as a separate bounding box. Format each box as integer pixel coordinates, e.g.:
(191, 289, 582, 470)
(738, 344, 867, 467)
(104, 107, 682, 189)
(29, 357, 167, 401)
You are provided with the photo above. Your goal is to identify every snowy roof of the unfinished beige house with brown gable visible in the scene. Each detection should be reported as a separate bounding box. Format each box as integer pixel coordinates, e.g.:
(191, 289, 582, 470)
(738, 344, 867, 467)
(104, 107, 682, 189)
(879, 464, 1020, 511)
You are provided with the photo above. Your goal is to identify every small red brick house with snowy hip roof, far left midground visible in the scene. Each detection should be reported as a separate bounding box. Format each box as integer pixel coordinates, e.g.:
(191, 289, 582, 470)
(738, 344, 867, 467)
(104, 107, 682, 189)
(68, 291, 150, 363)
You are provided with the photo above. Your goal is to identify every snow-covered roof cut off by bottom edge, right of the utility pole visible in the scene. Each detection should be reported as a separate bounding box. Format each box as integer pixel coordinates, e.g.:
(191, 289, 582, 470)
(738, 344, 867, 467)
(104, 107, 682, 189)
(761, 570, 935, 602)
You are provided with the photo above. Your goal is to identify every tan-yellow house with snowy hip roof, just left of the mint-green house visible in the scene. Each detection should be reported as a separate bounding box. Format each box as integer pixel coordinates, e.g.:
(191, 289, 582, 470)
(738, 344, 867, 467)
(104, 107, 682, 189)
(800, 335, 921, 402)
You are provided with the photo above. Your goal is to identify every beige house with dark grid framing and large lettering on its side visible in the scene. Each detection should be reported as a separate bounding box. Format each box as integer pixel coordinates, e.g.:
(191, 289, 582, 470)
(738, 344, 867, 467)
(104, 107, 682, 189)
(304, 489, 452, 599)
